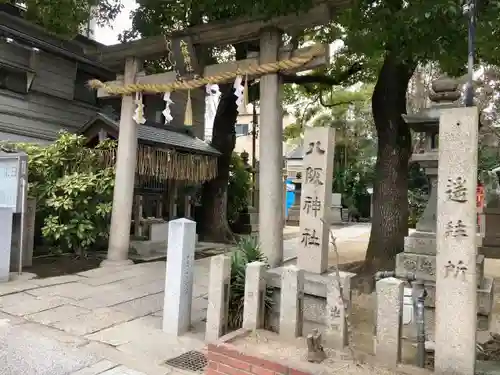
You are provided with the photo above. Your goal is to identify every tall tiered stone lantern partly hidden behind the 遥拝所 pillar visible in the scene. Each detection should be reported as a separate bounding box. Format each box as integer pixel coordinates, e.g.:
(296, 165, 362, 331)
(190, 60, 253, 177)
(396, 76, 493, 341)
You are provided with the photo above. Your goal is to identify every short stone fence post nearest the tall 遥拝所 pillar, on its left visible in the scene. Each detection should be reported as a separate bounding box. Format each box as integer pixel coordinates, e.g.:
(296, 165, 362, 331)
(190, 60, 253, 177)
(375, 277, 404, 366)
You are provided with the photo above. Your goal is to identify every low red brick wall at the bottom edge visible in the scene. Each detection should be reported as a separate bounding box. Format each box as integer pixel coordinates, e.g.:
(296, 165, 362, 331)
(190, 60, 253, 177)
(205, 343, 313, 375)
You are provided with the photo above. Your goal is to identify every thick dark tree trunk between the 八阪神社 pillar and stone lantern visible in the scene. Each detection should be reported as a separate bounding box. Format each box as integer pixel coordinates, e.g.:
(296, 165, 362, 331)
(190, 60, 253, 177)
(364, 52, 416, 272)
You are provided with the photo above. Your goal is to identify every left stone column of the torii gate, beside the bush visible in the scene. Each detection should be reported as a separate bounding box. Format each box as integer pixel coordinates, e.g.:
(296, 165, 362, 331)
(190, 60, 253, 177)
(101, 57, 141, 267)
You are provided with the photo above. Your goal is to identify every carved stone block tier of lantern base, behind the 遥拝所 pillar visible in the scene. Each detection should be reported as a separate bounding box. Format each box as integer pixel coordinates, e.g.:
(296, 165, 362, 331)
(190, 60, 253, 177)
(396, 251, 484, 287)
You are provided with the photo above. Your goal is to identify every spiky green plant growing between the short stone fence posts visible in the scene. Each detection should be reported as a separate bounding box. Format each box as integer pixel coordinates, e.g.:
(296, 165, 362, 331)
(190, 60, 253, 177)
(228, 236, 273, 330)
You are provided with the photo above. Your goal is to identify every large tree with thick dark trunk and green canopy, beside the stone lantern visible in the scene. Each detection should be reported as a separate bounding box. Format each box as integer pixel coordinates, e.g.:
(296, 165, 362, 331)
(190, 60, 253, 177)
(324, 0, 500, 271)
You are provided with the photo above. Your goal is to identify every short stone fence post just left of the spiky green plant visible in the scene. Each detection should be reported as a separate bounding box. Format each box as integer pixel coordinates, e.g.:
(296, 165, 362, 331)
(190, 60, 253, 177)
(205, 255, 231, 342)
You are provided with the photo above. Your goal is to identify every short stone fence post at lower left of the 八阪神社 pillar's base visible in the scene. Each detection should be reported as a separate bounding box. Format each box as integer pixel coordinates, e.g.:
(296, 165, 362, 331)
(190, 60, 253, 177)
(279, 266, 304, 339)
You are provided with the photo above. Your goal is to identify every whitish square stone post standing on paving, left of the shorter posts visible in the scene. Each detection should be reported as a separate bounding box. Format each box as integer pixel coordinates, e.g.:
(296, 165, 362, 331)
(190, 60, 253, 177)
(163, 219, 196, 336)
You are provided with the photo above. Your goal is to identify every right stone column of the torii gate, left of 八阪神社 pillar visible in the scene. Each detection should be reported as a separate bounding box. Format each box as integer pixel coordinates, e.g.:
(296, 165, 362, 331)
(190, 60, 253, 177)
(259, 29, 283, 267)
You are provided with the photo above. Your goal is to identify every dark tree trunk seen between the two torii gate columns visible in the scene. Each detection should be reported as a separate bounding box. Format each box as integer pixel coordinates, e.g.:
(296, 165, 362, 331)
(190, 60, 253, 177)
(200, 84, 238, 242)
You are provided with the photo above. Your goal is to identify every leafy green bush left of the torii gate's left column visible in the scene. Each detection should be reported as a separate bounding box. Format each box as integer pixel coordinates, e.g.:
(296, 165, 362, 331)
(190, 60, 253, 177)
(14, 132, 115, 255)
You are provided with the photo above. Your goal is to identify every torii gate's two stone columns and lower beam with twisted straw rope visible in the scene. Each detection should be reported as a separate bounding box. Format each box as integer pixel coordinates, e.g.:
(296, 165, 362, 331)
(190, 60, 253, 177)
(89, 22, 329, 267)
